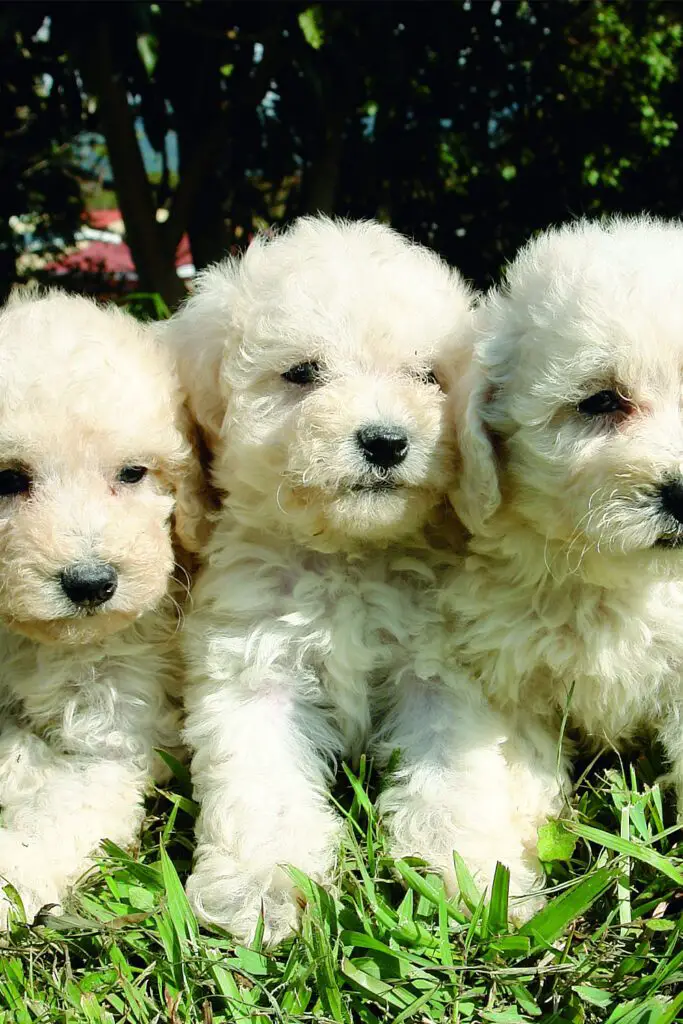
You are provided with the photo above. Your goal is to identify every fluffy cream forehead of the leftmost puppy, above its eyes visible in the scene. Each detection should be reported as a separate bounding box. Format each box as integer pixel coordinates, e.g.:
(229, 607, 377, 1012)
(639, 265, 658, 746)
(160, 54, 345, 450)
(0, 296, 175, 453)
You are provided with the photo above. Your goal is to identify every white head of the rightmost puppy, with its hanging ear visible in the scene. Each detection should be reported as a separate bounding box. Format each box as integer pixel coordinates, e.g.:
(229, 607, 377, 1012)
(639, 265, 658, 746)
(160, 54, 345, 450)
(454, 218, 683, 568)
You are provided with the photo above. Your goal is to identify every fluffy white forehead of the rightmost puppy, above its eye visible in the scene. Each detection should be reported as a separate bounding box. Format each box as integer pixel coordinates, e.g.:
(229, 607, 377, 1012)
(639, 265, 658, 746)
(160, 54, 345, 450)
(492, 220, 683, 382)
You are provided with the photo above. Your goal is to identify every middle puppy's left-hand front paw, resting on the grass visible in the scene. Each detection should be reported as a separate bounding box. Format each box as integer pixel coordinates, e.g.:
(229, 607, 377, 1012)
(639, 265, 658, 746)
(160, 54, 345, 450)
(186, 853, 300, 945)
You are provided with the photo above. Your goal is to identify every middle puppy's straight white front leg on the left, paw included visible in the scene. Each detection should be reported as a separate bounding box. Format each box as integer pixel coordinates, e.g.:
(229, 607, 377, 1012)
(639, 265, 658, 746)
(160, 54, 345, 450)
(185, 680, 340, 943)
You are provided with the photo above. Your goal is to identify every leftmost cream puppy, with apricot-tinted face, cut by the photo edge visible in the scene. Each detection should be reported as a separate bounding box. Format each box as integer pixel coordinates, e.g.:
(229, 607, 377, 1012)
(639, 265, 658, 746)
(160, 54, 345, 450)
(0, 292, 202, 928)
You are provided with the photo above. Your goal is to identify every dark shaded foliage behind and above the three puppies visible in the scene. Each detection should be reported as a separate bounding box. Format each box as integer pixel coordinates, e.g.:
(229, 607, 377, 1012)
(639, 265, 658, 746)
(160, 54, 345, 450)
(0, 0, 683, 304)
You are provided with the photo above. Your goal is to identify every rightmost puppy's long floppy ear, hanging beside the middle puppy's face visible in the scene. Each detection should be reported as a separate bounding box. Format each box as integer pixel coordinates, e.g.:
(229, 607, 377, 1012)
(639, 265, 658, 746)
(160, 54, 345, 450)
(449, 345, 501, 534)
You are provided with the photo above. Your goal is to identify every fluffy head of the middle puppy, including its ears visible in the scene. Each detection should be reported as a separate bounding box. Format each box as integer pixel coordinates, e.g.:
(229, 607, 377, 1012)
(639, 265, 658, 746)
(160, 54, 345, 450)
(171, 218, 470, 550)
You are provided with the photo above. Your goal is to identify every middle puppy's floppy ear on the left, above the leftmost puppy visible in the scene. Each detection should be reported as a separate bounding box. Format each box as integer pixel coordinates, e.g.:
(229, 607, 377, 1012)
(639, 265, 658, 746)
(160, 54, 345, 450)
(159, 257, 240, 450)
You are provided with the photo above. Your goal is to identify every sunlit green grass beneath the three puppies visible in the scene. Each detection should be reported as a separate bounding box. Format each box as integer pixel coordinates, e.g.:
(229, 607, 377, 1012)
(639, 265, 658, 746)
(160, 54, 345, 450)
(0, 758, 683, 1024)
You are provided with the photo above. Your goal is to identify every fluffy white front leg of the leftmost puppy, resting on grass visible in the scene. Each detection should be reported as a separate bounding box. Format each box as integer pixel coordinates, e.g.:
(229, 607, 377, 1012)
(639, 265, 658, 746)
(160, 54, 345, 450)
(0, 728, 145, 930)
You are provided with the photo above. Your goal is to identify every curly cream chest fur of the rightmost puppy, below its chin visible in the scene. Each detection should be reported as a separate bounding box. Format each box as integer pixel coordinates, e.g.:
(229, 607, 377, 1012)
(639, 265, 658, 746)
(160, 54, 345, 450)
(461, 586, 683, 740)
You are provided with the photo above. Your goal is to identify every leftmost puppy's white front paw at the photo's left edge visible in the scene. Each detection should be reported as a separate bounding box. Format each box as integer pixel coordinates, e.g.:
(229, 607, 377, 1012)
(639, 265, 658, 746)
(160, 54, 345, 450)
(0, 828, 61, 932)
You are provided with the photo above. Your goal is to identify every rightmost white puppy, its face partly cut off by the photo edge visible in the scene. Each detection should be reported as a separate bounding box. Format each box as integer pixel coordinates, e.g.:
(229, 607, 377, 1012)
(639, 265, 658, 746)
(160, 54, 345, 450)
(446, 218, 683, 909)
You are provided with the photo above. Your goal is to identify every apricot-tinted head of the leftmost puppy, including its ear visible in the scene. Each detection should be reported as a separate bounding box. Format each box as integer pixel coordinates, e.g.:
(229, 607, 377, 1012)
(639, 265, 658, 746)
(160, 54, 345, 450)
(0, 292, 201, 643)
